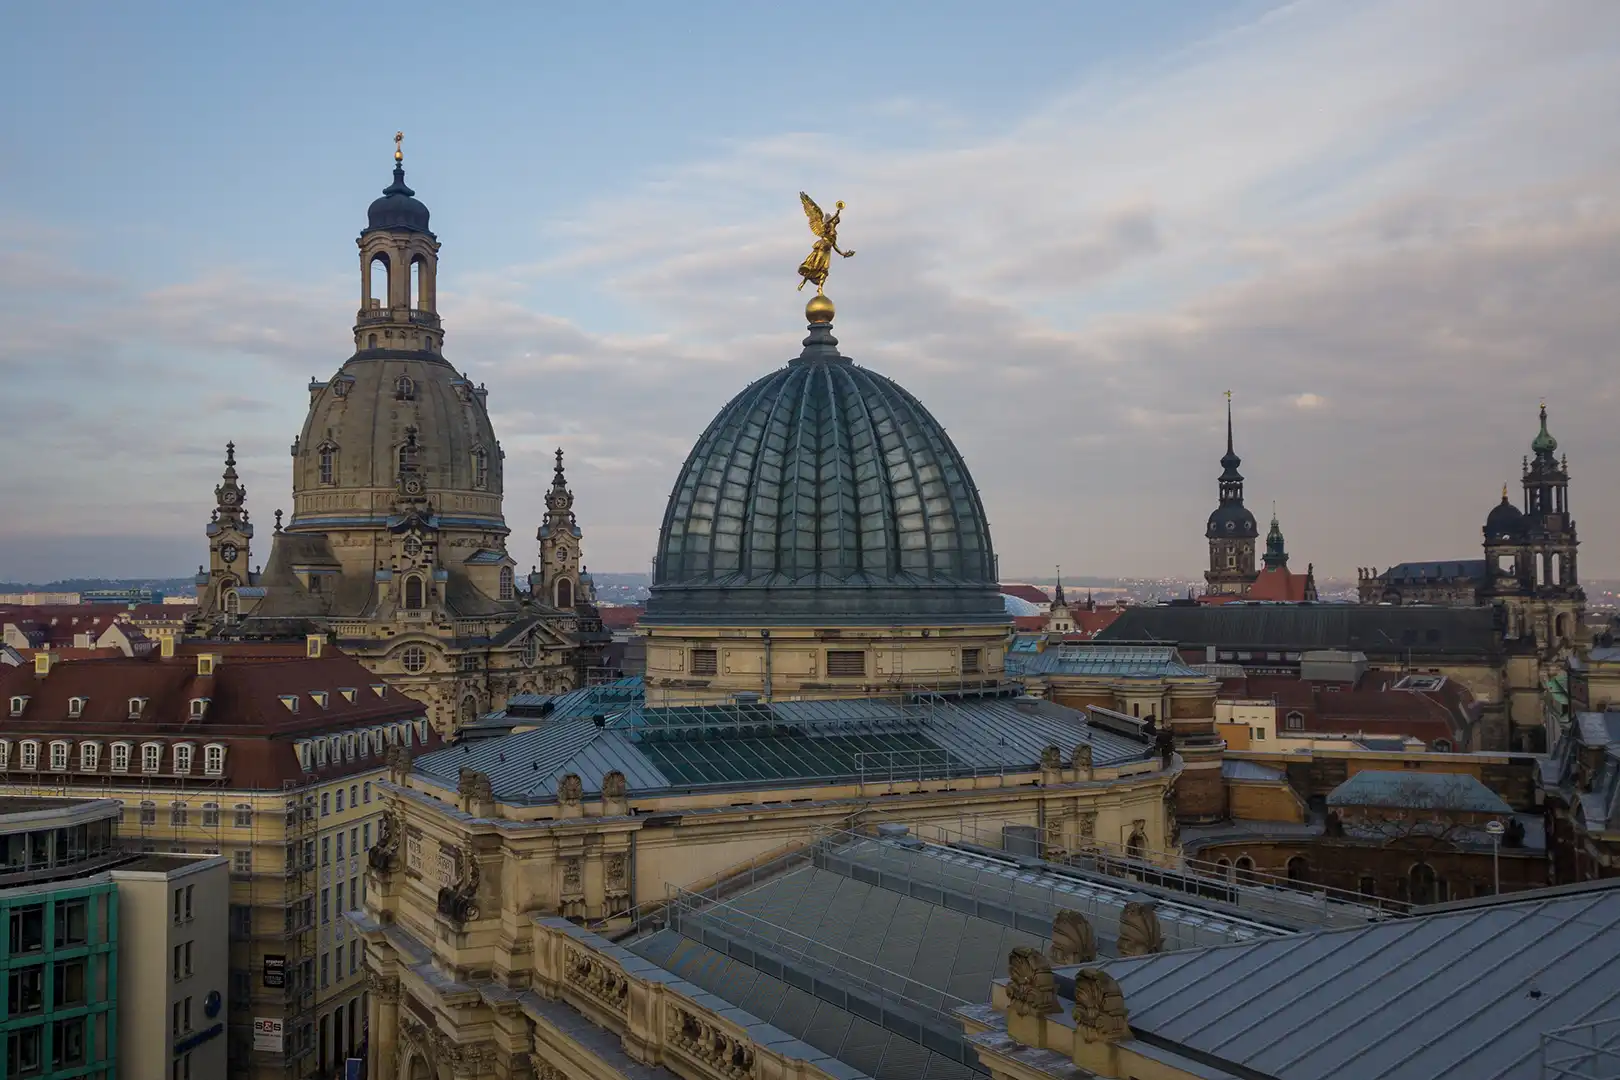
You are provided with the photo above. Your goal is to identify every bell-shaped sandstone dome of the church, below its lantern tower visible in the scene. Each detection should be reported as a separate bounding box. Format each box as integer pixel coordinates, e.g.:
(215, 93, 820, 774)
(293, 348, 505, 529)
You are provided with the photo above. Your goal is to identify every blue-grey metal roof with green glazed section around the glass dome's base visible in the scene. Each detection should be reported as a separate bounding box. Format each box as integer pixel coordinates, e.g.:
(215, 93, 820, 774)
(413, 687, 1153, 801)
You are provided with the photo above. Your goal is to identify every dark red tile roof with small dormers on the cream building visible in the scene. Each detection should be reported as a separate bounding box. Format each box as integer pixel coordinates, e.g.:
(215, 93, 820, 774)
(0, 646, 439, 790)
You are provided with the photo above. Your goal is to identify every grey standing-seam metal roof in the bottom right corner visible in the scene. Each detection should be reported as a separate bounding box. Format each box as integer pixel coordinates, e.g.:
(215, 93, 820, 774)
(1082, 889, 1620, 1080)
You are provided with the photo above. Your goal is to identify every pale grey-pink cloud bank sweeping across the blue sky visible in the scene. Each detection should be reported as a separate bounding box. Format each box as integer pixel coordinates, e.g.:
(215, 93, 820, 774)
(0, 0, 1620, 575)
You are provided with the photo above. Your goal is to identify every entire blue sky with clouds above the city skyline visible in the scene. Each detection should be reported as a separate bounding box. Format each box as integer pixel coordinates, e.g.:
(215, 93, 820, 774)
(0, 0, 1620, 581)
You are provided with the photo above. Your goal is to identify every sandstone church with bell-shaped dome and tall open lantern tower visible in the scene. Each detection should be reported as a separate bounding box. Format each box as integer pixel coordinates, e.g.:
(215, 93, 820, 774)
(199, 136, 598, 732)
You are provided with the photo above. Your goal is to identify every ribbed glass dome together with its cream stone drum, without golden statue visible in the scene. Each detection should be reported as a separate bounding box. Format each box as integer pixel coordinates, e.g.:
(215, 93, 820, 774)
(640, 295, 1009, 703)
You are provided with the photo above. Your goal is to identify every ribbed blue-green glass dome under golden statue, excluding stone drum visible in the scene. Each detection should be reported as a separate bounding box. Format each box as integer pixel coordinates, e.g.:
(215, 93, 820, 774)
(645, 298, 1008, 625)
